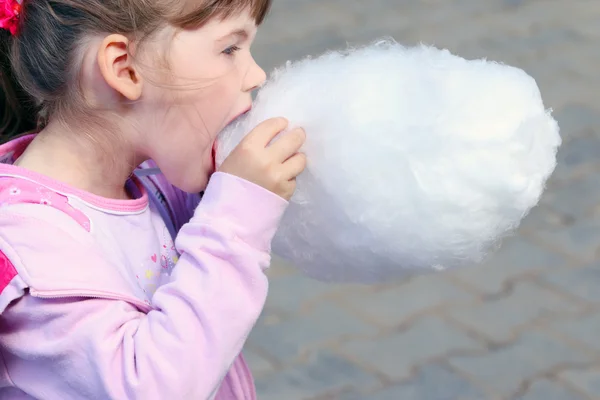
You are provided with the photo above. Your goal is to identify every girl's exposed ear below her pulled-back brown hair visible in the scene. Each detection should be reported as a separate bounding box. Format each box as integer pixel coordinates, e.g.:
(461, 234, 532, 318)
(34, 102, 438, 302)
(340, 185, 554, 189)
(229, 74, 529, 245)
(98, 34, 142, 100)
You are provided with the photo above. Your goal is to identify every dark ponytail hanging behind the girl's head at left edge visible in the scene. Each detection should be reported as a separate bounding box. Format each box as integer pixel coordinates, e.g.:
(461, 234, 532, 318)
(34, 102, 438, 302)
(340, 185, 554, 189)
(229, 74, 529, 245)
(0, 29, 37, 143)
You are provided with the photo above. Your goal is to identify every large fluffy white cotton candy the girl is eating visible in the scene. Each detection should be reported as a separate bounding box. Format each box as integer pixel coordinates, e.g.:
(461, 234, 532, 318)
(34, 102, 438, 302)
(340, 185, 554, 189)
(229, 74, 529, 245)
(217, 40, 561, 283)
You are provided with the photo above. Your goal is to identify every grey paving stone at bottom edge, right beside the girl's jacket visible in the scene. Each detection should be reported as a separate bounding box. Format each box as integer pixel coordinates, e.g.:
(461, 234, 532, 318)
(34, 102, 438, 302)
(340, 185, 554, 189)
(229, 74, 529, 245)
(255, 351, 378, 400)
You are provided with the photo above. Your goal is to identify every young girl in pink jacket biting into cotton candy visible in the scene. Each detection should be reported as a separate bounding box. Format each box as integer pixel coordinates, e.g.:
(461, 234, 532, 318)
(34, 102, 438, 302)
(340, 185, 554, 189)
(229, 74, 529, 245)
(0, 0, 305, 400)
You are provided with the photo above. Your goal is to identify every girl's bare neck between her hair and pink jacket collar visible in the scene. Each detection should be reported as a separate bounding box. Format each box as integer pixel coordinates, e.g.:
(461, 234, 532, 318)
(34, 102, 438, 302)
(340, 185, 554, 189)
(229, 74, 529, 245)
(15, 119, 141, 199)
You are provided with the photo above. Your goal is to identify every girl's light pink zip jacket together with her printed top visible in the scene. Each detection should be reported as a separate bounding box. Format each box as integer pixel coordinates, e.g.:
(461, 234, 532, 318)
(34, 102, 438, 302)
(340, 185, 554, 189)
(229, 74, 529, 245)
(0, 137, 287, 400)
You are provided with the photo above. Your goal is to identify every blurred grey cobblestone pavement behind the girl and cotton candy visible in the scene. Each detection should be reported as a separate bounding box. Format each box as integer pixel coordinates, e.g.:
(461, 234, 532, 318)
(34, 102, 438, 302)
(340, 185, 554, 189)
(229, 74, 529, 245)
(245, 0, 600, 400)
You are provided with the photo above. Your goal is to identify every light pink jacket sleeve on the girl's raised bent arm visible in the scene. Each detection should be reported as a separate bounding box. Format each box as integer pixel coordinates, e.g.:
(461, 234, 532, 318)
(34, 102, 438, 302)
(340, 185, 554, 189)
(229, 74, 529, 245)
(0, 174, 287, 400)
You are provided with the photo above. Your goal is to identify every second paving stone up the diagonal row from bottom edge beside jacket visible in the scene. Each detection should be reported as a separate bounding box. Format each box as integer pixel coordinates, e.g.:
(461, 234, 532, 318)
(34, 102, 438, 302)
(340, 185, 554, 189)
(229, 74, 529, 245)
(341, 317, 482, 379)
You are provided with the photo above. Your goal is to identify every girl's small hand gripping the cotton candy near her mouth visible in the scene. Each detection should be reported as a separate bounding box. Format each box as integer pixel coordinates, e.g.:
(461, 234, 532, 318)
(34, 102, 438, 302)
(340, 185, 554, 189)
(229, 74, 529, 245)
(219, 118, 306, 200)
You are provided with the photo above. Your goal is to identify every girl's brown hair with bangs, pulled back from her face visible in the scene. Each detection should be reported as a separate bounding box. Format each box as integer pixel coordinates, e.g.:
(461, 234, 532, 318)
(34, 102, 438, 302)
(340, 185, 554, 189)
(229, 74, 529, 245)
(0, 0, 271, 139)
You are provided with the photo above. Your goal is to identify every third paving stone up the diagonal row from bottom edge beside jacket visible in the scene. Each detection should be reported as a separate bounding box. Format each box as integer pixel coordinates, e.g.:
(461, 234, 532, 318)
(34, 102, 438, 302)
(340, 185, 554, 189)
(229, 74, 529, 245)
(448, 282, 578, 342)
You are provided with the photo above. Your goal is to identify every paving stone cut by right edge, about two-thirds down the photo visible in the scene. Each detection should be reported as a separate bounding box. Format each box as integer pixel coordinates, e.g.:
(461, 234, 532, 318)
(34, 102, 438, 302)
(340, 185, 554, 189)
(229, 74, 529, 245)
(543, 263, 600, 303)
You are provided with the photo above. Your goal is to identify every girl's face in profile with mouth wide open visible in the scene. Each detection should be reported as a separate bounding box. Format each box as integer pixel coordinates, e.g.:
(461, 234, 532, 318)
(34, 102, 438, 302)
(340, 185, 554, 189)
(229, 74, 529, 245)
(139, 7, 266, 193)
